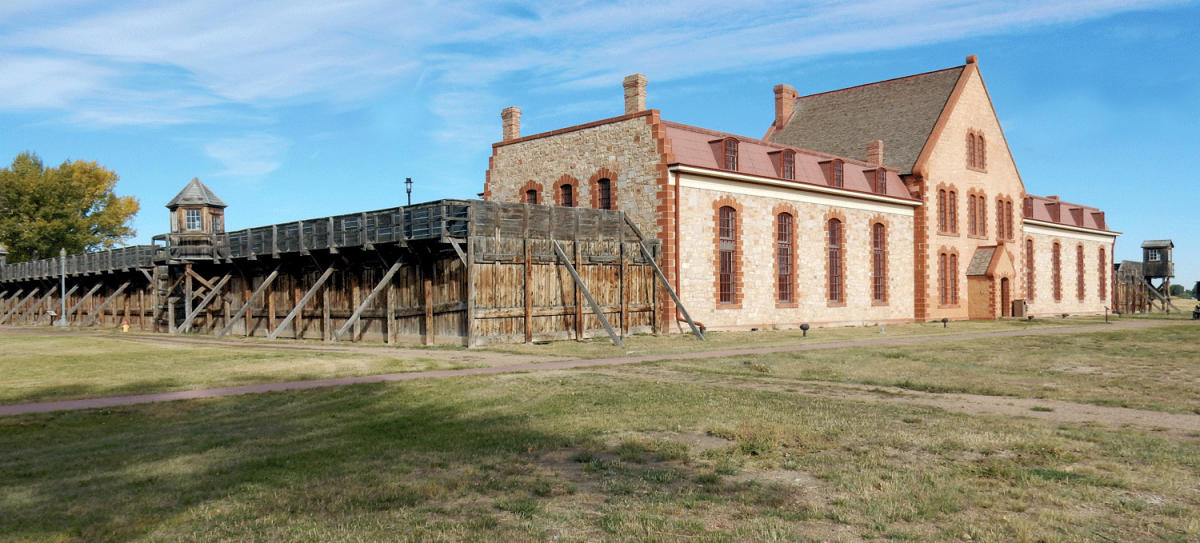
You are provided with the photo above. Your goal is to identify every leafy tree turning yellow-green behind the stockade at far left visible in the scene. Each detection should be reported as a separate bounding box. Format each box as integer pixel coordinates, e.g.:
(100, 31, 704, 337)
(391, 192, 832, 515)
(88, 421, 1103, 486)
(0, 151, 138, 262)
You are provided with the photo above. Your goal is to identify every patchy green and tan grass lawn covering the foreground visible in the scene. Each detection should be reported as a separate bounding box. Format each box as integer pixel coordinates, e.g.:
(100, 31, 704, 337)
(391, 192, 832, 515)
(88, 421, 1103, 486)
(0, 322, 1200, 542)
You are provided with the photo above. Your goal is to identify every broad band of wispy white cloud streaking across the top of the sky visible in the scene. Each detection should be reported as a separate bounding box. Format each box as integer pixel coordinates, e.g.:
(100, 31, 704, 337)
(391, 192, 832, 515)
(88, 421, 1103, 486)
(0, 0, 1180, 130)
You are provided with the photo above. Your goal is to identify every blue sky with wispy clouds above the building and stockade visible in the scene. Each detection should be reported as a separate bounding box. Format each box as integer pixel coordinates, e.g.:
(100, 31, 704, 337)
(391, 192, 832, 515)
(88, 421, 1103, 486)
(0, 0, 1200, 286)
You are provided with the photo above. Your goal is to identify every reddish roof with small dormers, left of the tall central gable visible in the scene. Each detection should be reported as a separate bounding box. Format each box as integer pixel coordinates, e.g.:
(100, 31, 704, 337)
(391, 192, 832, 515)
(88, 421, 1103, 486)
(662, 121, 916, 199)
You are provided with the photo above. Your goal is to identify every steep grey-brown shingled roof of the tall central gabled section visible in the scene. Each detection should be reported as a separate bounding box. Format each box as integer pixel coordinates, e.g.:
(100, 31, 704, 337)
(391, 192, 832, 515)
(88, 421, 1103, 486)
(769, 66, 966, 174)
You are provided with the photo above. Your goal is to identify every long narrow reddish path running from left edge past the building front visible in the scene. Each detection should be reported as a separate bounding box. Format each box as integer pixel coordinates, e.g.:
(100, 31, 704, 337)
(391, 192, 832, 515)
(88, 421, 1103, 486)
(0, 321, 1178, 416)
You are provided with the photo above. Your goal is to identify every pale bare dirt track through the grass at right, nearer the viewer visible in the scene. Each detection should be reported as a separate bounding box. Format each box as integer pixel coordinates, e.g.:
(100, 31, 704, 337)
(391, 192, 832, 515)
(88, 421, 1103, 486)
(601, 368, 1200, 437)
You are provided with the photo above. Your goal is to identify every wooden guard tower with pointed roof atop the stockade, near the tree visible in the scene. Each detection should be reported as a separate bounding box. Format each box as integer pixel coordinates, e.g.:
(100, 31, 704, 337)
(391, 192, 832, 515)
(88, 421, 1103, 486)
(158, 178, 227, 259)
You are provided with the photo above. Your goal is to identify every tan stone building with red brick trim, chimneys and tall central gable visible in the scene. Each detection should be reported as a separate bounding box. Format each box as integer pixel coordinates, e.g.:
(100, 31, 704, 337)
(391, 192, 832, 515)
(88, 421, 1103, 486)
(484, 55, 1117, 329)
